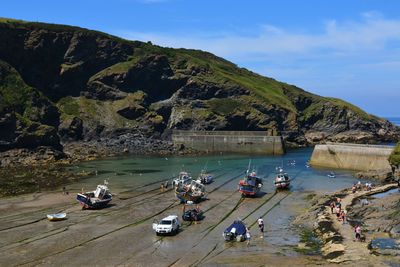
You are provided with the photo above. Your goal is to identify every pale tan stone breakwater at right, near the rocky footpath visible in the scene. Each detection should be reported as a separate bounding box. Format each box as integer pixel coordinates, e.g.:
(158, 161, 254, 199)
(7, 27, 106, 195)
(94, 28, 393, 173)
(310, 143, 394, 171)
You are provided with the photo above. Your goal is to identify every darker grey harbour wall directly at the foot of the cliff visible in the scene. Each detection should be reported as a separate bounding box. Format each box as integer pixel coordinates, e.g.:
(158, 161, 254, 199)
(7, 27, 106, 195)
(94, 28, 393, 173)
(172, 130, 284, 155)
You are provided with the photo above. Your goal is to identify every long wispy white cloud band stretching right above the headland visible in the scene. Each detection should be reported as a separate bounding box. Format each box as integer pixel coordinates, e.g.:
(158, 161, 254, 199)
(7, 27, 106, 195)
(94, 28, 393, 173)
(119, 12, 400, 59)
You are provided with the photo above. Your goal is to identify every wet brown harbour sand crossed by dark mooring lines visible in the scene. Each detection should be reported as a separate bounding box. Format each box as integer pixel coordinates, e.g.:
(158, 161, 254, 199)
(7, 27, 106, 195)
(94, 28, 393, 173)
(0, 171, 326, 266)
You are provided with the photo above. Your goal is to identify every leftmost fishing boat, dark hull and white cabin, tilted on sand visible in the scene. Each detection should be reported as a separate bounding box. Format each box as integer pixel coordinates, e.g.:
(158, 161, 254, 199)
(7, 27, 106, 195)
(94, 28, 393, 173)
(76, 181, 112, 209)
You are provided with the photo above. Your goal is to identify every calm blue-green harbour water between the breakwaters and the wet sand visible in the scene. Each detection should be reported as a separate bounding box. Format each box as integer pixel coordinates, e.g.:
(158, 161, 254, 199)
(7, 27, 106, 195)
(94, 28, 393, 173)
(69, 148, 356, 196)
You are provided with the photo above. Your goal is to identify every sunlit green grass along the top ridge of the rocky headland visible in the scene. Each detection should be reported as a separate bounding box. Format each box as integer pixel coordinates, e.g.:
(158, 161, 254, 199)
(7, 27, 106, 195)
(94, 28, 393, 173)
(0, 18, 371, 124)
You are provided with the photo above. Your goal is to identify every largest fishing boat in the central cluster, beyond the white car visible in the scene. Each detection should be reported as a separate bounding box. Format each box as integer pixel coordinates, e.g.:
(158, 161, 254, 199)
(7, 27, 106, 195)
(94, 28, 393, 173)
(175, 179, 206, 203)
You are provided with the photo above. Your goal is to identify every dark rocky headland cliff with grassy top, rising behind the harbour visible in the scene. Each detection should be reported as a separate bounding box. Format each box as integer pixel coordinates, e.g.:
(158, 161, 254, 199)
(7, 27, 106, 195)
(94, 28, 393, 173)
(0, 19, 399, 161)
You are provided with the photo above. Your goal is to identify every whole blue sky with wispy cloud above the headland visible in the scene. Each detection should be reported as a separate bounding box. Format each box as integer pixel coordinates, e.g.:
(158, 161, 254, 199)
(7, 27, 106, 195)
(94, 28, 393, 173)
(0, 0, 400, 117)
